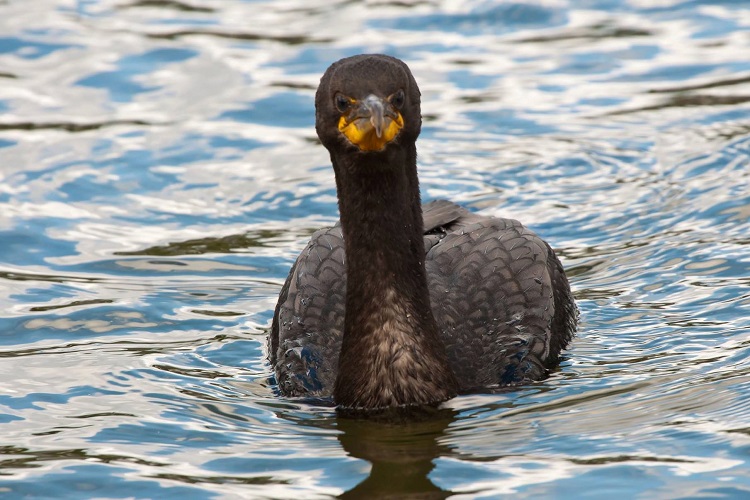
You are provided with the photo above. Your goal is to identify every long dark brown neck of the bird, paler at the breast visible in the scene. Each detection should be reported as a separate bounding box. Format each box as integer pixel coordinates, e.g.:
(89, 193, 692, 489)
(332, 146, 457, 408)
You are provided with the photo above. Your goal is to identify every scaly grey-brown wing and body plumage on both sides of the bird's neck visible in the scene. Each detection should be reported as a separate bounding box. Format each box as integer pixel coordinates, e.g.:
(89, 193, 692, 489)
(269, 200, 577, 397)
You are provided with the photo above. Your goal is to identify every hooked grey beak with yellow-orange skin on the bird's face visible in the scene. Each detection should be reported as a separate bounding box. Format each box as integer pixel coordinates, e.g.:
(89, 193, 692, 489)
(339, 94, 404, 151)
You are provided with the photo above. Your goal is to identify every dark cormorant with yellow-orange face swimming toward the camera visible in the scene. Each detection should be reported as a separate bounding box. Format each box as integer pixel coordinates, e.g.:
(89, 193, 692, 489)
(269, 54, 578, 411)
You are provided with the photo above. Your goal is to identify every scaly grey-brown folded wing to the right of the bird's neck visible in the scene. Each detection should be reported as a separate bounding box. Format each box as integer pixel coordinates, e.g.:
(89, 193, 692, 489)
(426, 202, 575, 391)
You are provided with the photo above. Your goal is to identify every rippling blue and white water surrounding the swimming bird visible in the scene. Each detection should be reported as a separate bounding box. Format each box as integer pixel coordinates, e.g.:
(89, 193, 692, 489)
(0, 0, 750, 498)
